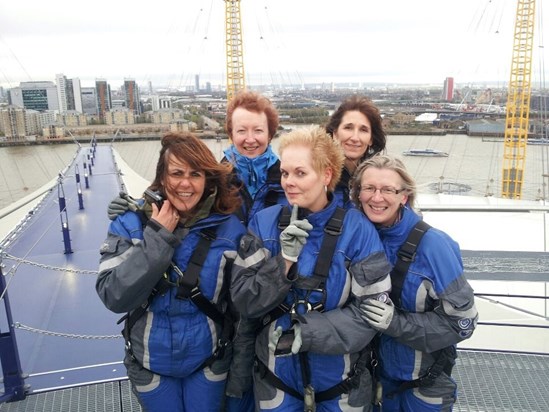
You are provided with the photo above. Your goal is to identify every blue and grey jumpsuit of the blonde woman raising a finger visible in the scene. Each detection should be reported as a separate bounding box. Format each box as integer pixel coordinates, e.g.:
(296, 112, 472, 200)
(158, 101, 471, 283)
(231, 200, 390, 411)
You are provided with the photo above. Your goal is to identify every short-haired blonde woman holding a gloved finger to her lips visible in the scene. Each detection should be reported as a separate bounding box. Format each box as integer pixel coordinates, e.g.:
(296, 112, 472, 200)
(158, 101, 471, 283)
(231, 127, 390, 411)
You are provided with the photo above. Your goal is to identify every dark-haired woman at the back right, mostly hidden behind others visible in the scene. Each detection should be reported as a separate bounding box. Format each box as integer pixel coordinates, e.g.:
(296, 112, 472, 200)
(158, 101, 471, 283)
(326, 95, 387, 208)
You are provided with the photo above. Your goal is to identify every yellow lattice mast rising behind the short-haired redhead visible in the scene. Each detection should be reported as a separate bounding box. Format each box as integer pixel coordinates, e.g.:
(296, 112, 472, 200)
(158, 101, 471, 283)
(224, 0, 246, 101)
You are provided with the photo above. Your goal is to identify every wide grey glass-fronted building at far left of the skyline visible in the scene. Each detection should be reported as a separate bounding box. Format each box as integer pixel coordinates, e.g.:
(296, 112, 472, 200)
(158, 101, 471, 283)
(8, 82, 59, 112)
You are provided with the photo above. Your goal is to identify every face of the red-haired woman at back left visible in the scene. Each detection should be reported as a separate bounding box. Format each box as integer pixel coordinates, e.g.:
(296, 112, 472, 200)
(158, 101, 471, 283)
(231, 107, 269, 159)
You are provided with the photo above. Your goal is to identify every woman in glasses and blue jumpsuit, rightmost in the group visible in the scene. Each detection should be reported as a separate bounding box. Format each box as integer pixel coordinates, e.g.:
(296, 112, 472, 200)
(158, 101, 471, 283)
(351, 155, 478, 412)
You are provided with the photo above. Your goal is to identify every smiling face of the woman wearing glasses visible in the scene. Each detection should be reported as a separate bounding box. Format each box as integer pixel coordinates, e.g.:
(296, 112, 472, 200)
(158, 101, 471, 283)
(358, 167, 408, 226)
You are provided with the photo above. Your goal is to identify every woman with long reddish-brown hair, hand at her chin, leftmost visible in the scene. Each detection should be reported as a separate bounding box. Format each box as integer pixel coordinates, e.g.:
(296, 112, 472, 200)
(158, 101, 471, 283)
(96, 133, 246, 412)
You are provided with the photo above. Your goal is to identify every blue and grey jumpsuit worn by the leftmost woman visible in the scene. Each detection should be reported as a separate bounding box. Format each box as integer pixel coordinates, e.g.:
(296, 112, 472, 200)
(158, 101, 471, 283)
(96, 211, 246, 412)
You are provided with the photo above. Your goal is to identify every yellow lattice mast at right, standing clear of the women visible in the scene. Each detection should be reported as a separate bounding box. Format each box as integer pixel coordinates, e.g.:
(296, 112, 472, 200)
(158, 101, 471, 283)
(501, 0, 536, 199)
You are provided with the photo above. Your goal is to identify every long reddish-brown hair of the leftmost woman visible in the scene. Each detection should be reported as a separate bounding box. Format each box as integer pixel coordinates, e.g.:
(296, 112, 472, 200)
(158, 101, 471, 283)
(151, 132, 241, 214)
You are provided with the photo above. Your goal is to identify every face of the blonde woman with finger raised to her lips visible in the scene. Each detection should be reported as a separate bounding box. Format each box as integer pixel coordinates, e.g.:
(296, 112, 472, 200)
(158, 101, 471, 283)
(280, 145, 332, 212)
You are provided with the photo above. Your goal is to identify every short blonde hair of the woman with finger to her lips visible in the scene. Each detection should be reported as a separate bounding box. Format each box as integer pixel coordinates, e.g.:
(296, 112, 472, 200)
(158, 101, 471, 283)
(278, 126, 345, 192)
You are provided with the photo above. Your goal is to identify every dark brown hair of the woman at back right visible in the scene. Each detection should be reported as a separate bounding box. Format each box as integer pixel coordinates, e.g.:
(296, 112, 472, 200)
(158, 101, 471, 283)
(326, 94, 387, 161)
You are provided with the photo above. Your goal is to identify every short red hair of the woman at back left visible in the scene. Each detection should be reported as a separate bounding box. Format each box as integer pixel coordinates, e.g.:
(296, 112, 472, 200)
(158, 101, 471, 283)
(225, 91, 279, 141)
